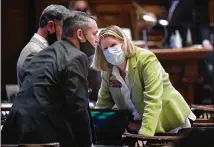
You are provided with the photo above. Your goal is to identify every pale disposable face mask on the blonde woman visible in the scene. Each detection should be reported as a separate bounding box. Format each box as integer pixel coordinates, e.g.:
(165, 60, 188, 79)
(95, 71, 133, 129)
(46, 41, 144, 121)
(104, 44, 125, 65)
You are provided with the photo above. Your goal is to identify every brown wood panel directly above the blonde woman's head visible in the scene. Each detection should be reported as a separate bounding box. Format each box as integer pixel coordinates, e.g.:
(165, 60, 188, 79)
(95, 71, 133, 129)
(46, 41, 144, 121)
(89, 0, 136, 38)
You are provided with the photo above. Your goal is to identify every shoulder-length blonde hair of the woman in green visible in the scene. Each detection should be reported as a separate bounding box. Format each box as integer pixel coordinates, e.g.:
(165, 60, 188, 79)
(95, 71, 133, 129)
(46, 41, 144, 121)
(91, 25, 136, 71)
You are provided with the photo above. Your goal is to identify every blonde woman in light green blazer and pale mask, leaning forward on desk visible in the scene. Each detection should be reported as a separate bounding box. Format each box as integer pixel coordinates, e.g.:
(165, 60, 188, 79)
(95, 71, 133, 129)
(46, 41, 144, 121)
(92, 26, 195, 136)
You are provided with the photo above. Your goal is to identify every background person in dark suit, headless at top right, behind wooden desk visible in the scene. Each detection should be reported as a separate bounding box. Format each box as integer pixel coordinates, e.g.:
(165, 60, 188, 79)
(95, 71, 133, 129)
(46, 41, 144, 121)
(160, 0, 212, 48)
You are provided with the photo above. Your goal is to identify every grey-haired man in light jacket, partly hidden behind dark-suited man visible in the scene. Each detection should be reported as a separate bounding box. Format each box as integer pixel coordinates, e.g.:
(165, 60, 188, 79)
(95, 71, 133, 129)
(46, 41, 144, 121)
(17, 5, 70, 87)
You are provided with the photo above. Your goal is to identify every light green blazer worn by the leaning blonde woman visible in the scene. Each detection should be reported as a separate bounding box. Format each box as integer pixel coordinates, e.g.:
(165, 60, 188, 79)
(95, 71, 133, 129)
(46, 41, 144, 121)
(95, 47, 191, 136)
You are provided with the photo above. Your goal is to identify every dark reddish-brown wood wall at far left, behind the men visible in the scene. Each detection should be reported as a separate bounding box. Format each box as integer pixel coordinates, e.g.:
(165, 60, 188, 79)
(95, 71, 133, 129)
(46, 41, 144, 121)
(1, 0, 28, 99)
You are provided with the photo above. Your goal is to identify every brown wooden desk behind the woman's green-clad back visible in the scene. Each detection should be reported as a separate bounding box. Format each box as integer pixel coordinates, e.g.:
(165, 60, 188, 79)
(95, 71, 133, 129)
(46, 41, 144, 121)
(151, 48, 212, 104)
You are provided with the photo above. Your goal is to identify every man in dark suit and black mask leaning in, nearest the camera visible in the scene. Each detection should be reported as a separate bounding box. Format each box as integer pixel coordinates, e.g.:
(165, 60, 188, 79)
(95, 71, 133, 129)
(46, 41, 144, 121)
(1, 11, 99, 147)
